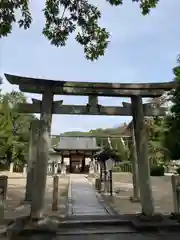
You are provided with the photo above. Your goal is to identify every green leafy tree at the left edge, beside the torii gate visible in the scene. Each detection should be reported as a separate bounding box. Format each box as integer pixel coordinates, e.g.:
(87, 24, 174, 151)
(0, 91, 35, 169)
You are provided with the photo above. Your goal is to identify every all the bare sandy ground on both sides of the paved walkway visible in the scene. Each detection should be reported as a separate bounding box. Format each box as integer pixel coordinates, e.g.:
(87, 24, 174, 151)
(1, 172, 176, 219)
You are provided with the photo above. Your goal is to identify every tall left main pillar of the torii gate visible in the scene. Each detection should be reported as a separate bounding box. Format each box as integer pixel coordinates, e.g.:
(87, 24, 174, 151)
(31, 86, 53, 219)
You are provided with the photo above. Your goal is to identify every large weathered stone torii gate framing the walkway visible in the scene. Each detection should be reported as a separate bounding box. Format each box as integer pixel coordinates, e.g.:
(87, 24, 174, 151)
(5, 74, 175, 218)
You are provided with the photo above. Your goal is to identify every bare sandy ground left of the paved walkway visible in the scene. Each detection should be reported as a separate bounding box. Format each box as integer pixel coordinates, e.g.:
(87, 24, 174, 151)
(0, 172, 69, 220)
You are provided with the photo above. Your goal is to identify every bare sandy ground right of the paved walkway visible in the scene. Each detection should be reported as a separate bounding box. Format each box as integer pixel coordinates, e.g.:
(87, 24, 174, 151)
(92, 173, 173, 214)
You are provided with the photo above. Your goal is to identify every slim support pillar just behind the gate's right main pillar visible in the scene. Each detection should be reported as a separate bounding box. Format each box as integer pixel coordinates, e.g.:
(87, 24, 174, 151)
(130, 126, 140, 202)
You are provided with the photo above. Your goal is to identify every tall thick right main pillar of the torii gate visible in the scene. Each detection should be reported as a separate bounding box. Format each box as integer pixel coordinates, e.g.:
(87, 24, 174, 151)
(131, 96, 154, 216)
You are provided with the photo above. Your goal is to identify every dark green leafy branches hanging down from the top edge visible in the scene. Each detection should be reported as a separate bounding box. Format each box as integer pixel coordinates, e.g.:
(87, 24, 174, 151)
(0, 0, 159, 60)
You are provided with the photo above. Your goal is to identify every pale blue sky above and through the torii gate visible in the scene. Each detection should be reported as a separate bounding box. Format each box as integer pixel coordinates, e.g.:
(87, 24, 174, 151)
(0, 0, 180, 134)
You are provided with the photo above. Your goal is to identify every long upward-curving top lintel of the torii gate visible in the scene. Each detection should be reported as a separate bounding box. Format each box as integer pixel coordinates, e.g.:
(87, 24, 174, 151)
(5, 74, 176, 97)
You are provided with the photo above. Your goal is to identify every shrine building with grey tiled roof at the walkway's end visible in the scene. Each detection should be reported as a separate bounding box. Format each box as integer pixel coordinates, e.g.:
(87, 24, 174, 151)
(48, 136, 100, 173)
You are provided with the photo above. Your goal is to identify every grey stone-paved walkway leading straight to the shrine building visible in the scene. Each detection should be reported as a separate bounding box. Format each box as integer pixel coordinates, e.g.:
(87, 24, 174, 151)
(68, 174, 109, 216)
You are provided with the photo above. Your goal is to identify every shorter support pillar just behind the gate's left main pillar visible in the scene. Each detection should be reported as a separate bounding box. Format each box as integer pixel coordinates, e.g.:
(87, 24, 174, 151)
(25, 120, 40, 201)
